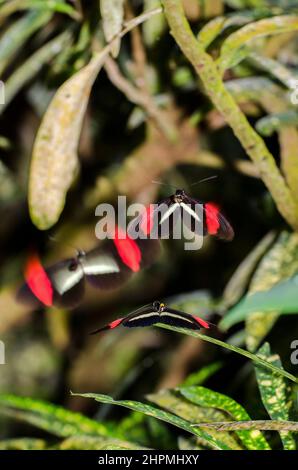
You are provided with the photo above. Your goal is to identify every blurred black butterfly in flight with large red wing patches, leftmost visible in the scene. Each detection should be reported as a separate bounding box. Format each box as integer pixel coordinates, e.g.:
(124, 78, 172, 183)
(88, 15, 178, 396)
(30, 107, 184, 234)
(17, 227, 159, 307)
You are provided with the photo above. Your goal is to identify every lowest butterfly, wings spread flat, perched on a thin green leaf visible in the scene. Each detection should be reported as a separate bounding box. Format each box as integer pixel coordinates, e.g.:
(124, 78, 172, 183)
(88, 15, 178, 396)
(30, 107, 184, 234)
(91, 300, 210, 335)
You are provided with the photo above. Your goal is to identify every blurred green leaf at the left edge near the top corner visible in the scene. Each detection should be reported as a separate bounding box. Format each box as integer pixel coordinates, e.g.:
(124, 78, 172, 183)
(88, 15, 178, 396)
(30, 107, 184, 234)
(0, 11, 52, 76)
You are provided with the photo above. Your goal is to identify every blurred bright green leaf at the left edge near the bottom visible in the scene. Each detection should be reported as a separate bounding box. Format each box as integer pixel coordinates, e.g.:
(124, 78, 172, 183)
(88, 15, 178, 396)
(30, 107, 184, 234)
(0, 395, 109, 437)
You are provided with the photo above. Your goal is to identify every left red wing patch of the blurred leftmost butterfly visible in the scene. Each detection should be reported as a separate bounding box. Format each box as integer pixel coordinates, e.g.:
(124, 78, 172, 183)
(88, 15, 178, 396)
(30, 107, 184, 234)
(25, 254, 53, 307)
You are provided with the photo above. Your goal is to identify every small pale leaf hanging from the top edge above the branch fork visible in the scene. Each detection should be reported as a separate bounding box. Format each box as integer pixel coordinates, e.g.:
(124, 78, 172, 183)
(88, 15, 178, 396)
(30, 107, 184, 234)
(100, 0, 124, 57)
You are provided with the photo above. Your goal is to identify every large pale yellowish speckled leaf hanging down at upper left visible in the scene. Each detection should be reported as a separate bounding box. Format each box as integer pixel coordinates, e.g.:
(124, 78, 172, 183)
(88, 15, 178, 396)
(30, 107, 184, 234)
(28, 48, 108, 230)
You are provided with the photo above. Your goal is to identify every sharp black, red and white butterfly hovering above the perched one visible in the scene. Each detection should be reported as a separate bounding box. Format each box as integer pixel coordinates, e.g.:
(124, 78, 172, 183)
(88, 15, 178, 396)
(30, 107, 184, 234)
(130, 189, 234, 241)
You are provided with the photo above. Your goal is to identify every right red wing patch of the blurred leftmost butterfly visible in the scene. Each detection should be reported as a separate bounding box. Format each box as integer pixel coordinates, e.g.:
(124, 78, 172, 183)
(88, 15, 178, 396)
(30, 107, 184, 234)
(113, 227, 142, 273)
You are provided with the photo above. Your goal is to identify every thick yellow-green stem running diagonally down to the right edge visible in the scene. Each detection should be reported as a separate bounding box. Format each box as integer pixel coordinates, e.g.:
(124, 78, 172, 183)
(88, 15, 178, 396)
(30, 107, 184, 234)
(162, 0, 298, 230)
